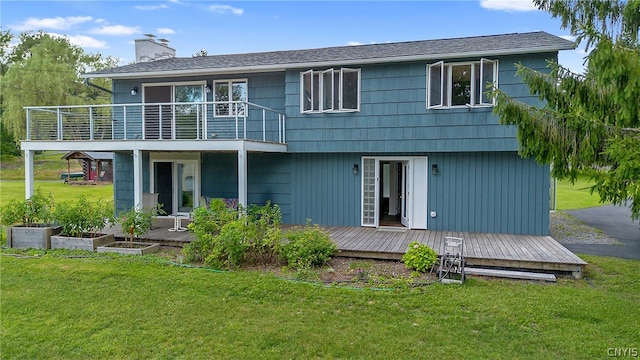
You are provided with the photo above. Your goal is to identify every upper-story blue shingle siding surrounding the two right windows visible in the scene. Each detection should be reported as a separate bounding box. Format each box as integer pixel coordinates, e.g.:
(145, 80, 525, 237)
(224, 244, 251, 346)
(285, 53, 557, 153)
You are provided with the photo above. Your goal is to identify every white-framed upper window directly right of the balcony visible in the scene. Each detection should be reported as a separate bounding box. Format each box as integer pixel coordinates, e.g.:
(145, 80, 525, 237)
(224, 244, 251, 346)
(300, 68, 360, 113)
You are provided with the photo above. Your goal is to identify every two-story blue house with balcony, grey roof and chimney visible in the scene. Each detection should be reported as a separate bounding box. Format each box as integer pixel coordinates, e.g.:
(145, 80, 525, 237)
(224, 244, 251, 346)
(22, 32, 574, 235)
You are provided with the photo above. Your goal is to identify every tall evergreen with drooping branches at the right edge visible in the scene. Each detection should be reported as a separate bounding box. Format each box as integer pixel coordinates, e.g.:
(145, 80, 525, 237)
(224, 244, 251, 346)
(492, 0, 640, 219)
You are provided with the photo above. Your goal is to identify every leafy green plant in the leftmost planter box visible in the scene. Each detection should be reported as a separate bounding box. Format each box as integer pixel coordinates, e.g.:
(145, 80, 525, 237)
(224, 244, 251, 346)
(0, 189, 55, 226)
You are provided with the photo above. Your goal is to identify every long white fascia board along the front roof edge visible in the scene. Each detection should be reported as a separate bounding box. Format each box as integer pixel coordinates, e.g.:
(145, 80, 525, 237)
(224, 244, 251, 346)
(80, 44, 576, 79)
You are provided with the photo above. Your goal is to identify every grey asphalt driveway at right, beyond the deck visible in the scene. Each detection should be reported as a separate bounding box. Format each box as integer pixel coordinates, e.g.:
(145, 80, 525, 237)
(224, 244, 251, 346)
(564, 205, 640, 260)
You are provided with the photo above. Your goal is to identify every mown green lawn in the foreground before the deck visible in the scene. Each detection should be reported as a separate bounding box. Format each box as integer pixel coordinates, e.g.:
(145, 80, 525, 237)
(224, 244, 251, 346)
(0, 250, 640, 359)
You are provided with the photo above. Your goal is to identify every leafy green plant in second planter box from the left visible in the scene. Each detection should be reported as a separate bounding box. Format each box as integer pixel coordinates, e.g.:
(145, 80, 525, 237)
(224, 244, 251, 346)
(53, 195, 115, 237)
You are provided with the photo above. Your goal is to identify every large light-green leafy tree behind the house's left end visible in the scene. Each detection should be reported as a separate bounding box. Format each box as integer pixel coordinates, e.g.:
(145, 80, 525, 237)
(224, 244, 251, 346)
(2, 32, 116, 139)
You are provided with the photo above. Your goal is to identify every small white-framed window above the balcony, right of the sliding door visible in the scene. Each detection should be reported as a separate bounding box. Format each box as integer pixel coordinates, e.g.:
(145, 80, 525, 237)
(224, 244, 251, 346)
(213, 79, 248, 116)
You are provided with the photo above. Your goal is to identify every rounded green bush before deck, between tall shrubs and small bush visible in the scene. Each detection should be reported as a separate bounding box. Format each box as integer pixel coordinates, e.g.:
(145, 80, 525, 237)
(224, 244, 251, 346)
(282, 223, 338, 269)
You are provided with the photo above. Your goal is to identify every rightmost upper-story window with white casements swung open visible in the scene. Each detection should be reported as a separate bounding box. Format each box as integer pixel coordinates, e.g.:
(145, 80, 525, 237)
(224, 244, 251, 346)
(427, 59, 498, 109)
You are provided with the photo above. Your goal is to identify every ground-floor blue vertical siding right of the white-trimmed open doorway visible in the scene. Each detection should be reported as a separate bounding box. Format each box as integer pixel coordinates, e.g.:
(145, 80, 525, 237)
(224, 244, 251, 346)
(427, 152, 549, 235)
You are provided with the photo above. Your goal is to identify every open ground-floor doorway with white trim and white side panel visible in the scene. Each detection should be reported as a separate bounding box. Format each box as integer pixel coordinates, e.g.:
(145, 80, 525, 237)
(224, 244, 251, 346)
(362, 157, 427, 229)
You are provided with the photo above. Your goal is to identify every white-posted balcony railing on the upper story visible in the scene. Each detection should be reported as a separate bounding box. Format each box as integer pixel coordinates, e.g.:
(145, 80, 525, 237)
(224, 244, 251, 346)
(25, 101, 286, 143)
